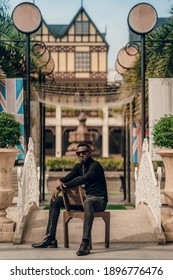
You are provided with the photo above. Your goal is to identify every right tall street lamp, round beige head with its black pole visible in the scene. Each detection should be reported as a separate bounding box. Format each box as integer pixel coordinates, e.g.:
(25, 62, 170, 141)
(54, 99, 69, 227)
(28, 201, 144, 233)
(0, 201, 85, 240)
(127, 3, 157, 142)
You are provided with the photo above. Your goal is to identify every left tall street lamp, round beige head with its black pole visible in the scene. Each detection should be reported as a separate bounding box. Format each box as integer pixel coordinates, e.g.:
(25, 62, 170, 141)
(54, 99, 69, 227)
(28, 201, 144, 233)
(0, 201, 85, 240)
(12, 2, 42, 150)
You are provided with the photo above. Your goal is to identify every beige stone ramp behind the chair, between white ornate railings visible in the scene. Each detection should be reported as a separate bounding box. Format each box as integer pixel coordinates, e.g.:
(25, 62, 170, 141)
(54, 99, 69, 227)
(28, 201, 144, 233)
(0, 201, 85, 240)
(23, 210, 157, 245)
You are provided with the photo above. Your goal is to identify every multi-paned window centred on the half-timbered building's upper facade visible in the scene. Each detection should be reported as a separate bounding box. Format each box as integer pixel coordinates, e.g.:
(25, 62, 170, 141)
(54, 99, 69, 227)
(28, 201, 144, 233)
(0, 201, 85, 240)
(75, 52, 90, 72)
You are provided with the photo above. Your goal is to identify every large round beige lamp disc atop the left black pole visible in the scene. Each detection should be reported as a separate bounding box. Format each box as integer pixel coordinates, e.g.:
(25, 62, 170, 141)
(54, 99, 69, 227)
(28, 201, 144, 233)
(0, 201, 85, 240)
(12, 2, 42, 34)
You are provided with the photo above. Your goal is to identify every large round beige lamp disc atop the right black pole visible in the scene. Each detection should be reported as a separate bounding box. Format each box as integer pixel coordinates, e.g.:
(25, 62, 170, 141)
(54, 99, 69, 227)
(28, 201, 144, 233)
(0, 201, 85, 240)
(127, 3, 157, 34)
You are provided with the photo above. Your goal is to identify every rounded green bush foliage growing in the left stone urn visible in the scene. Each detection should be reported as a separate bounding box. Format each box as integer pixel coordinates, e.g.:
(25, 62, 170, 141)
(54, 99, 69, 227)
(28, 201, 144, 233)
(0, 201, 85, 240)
(0, 112, 21, 148)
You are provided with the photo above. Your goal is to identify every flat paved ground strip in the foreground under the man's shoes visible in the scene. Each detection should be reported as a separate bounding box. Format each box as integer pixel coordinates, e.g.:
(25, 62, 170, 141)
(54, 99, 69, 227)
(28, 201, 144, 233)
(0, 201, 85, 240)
(0, 243, 173, 260)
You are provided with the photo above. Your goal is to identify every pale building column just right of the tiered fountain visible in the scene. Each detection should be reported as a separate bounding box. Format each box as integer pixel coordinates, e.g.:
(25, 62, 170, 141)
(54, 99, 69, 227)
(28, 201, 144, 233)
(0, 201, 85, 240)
(102, 106, 109, 157)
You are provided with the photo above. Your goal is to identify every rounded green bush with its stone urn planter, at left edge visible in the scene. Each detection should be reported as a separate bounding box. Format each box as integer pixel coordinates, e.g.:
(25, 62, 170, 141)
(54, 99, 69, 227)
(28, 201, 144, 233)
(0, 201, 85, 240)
(0, 112, 21, 242)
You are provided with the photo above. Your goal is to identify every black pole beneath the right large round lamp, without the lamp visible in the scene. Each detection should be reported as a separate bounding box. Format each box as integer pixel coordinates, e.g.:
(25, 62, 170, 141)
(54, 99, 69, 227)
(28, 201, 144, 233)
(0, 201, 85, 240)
(141, 34, 146, 143)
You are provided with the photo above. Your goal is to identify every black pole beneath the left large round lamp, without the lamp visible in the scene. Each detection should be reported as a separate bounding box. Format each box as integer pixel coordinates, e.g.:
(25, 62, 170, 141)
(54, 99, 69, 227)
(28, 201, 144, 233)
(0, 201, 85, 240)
(25, 34, 30, 151)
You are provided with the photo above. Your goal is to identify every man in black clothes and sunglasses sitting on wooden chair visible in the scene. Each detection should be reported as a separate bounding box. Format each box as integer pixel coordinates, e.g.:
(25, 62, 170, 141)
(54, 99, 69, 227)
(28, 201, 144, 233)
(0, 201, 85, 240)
(32, 143, 108, 256)
